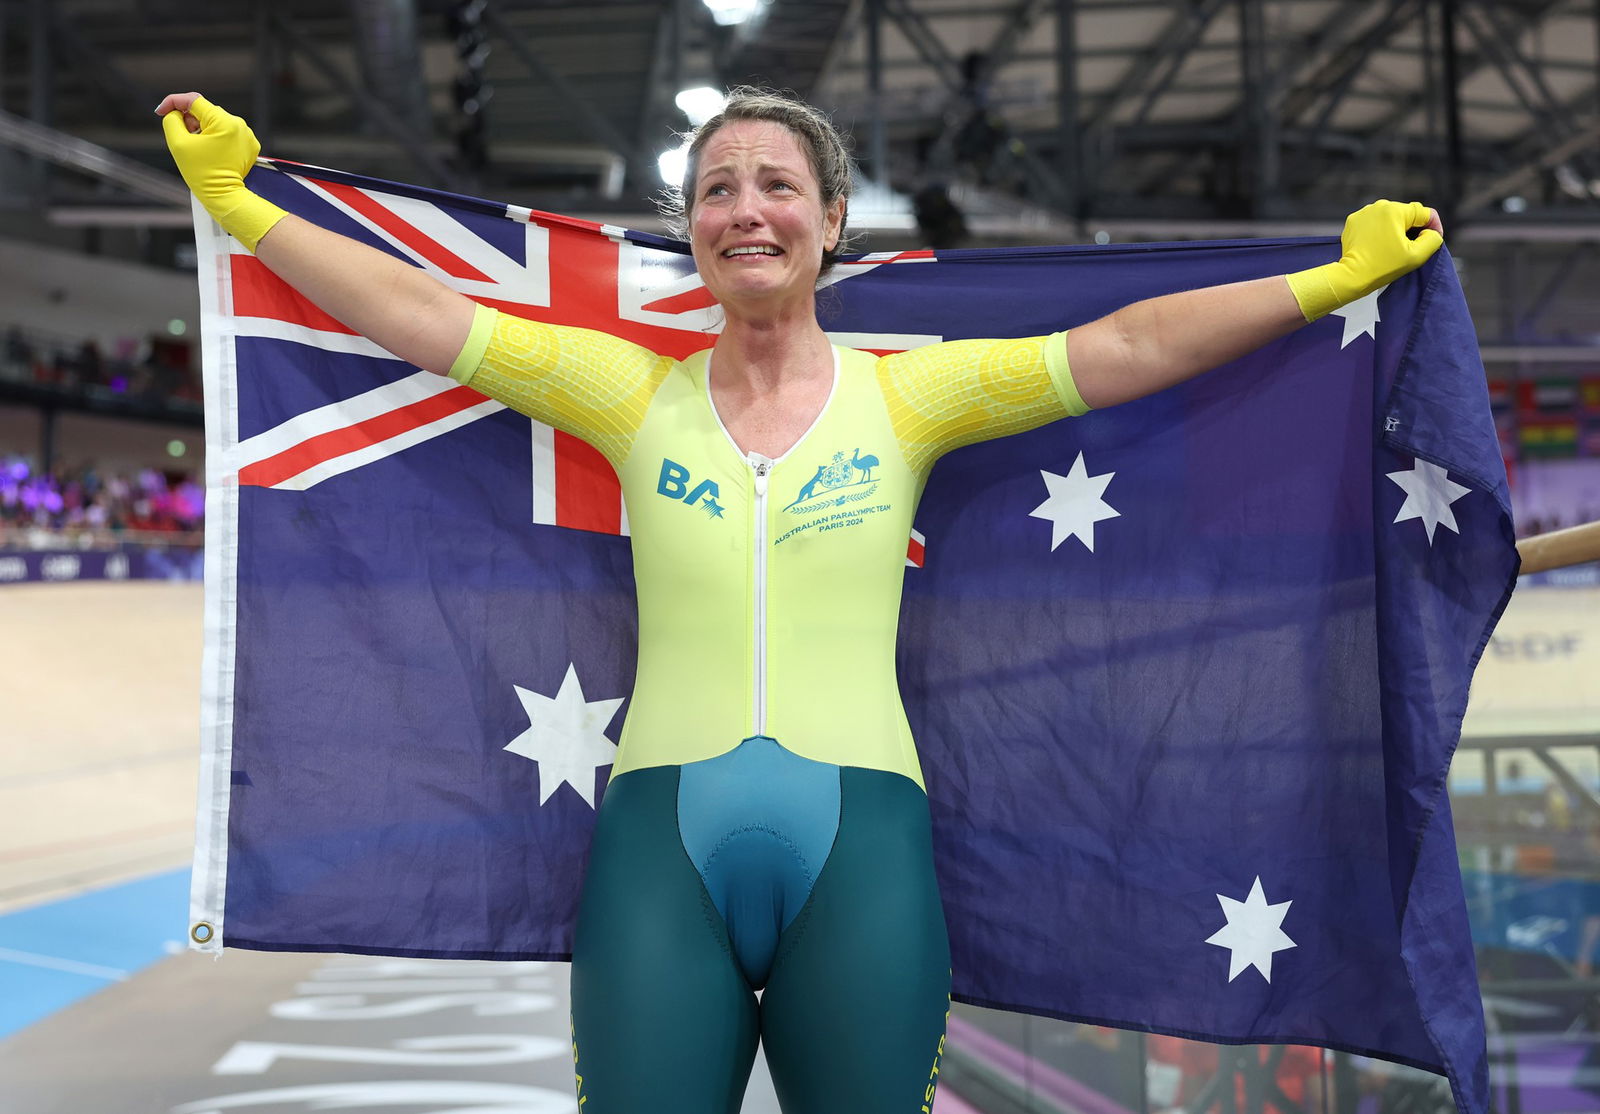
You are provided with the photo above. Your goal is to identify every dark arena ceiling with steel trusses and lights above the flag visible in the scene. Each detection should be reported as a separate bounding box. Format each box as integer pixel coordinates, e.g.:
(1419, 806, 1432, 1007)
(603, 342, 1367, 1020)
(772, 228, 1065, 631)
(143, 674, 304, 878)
(0, 0, 1600, 356)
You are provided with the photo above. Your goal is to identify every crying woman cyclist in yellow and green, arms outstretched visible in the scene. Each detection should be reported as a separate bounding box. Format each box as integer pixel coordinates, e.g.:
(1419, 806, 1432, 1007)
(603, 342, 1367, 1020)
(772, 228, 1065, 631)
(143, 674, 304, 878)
(157, 90, 1442, 1114)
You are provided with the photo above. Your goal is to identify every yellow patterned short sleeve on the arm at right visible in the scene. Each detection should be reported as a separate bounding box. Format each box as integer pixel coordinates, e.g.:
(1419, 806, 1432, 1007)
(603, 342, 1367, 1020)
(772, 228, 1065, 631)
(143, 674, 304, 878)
(878, 331, 1090, 474)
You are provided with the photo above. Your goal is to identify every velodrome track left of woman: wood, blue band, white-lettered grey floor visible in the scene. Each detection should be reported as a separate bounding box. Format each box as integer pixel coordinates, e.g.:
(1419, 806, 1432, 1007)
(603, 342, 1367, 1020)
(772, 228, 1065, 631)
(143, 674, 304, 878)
(0, 583, 806, 1114)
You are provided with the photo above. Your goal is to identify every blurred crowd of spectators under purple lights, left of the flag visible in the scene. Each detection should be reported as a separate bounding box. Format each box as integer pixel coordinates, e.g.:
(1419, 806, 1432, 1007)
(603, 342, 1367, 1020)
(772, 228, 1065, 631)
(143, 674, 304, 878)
(0, 456, 205, 547)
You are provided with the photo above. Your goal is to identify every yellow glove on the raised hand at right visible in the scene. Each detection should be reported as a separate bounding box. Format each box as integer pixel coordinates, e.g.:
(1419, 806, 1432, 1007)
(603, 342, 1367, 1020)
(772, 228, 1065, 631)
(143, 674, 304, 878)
(1285, 202, 1445, 322)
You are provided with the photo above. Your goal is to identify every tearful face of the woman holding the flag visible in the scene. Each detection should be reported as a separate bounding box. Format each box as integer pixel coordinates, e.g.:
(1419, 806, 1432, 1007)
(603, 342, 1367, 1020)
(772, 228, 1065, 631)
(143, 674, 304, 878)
(690, 120, 845, 307)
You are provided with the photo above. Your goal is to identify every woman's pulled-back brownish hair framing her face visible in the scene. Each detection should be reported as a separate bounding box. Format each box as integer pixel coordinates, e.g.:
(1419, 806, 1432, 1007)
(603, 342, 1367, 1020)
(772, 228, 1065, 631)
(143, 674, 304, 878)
(659, 85, 853, 279)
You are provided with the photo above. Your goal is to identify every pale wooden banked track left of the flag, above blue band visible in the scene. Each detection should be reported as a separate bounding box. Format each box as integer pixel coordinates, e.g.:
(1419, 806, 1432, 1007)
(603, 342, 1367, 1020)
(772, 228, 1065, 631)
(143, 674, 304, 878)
(0, 583, 200, 915)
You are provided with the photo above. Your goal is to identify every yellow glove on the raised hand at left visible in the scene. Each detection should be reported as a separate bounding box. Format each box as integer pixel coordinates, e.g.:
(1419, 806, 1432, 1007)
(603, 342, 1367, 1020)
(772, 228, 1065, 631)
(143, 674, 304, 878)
(162, 96, 288, 251)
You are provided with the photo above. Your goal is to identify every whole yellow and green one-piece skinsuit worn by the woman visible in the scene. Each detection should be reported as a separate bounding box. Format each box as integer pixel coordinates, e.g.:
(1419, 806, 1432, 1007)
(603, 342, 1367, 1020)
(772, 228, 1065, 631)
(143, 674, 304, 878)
(451, 309, 1085, 1114)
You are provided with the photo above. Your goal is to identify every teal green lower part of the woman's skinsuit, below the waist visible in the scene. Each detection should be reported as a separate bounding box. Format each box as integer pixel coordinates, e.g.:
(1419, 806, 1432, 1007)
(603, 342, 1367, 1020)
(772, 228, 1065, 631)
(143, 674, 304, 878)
(573, 736, 950, 1114)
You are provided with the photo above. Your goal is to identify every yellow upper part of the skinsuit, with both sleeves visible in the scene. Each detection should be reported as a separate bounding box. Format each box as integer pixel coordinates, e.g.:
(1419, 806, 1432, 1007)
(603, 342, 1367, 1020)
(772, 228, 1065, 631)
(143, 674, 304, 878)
(450, 306, 1088, 786)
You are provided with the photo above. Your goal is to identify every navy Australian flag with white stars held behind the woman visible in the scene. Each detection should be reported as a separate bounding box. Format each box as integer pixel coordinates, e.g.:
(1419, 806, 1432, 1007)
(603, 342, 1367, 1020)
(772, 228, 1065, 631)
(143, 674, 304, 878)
(192, 163, 1517, 1112)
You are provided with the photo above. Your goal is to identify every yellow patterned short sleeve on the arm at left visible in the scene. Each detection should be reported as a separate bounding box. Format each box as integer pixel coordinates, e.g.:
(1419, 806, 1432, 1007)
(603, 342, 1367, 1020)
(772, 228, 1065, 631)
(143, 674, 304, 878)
(450, 306, 672, 466)
